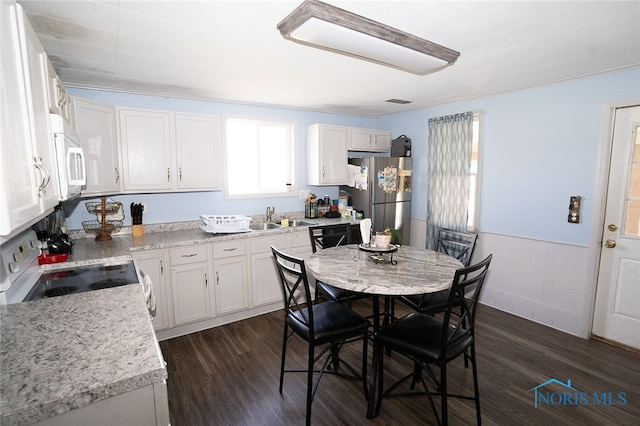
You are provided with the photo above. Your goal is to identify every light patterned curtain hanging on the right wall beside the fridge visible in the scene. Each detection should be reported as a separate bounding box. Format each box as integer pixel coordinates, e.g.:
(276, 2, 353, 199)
(427, 112, 473, 249)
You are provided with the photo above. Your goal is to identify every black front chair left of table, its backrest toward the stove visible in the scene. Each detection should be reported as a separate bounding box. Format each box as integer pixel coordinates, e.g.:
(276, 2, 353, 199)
(271, 246, 369, 425)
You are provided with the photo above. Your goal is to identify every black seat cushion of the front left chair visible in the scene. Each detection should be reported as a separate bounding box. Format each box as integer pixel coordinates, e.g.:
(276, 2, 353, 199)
(287, 301, 369, 344)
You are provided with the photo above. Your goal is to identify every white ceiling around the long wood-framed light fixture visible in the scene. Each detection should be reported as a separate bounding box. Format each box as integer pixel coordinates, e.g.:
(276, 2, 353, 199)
(18, 0, 640, 117)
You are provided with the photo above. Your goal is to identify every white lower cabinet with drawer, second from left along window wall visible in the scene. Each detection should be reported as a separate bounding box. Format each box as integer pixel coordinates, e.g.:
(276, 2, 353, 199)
(169, 244, 213, 325)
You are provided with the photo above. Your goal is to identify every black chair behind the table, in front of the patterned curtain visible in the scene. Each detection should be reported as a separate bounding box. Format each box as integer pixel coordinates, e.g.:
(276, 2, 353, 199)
(393, 228, 478, 315)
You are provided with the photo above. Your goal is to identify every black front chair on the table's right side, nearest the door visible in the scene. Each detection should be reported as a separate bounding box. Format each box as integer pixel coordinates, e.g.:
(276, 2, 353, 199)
(372, 255, 493, 425)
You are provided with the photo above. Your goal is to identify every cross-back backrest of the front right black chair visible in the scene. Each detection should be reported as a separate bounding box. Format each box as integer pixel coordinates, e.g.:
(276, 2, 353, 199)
(441, 254, 493, 359)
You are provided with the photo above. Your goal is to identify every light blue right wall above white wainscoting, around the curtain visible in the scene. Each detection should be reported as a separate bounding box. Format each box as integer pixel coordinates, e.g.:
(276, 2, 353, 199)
(378, 69, 640, 245)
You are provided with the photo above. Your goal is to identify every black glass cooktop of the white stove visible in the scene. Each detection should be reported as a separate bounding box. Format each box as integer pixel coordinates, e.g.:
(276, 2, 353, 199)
(24, 261, 138, 301)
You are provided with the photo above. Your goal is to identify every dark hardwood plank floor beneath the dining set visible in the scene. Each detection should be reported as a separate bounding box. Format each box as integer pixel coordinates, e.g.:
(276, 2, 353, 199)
(160, 300, 640, 426)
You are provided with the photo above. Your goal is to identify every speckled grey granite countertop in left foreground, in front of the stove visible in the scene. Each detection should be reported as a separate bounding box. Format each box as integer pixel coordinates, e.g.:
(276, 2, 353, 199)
(0, 285, 167, 425)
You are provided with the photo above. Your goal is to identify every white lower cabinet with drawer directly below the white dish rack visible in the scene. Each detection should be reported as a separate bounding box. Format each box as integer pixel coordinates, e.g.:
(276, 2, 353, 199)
(213, 240, 249, 315)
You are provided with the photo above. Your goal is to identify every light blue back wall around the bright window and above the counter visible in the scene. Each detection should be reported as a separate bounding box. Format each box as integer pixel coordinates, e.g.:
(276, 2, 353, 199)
(63, 89, 376, 229)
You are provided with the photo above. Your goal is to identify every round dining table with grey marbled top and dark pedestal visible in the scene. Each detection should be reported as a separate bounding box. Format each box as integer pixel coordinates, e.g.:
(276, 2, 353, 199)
(306, 244, 463, 418)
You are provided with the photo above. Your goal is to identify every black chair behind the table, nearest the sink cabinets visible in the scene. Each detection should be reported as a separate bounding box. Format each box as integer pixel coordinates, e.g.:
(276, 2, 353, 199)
(309, 223, 367, 307)
